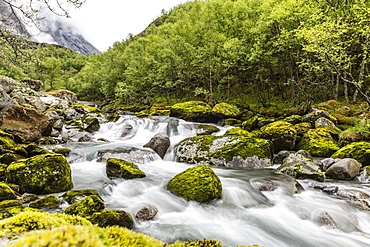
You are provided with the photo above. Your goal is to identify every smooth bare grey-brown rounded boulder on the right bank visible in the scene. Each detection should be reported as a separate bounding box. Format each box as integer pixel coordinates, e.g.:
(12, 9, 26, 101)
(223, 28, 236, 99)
(325, 158, 361, 180)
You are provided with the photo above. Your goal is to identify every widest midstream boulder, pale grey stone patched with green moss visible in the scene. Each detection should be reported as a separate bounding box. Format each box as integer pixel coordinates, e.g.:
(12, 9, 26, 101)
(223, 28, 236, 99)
(175, 129, 272, 168)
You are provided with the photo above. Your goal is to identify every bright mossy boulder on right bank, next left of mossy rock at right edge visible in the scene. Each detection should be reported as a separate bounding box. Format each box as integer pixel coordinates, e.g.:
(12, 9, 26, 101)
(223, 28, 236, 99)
(298, 128, 339, 157)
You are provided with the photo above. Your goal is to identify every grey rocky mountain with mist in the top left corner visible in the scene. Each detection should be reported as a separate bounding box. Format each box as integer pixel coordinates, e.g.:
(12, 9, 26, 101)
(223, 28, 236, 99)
(0, 0, 100, 55)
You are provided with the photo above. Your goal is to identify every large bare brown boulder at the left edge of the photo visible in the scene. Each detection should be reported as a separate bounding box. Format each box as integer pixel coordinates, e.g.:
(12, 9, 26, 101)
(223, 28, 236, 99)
(0, 105, 49, 141)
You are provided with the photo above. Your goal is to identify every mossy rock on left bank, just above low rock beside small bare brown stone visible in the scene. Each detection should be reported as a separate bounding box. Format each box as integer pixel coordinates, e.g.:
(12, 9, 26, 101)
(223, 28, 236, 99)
(64, 195, 105, 219)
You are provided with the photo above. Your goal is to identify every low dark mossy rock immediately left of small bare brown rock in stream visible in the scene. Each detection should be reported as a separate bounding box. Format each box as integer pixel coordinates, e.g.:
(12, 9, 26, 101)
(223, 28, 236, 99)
(90, 209, 134, 229)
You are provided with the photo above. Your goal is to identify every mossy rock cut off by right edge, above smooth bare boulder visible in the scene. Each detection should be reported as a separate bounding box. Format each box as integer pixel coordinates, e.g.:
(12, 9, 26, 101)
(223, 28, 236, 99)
(331, 142, 370, 166)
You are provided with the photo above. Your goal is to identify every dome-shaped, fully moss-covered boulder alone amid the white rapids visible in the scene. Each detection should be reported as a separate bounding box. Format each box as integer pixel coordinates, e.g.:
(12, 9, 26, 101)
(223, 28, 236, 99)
(167, 165, 222, 203)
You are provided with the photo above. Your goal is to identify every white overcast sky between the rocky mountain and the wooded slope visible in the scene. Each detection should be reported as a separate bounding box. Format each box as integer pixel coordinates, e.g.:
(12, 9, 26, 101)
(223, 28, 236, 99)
(64, 0, 189, 51)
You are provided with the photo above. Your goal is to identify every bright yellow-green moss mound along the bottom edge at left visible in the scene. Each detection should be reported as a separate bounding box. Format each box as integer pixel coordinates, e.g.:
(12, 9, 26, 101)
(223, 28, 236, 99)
(9, 226, 109, 247)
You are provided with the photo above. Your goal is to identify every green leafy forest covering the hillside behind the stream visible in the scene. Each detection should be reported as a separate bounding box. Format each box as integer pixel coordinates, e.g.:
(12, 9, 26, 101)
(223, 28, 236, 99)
(0, 0, 370, 110)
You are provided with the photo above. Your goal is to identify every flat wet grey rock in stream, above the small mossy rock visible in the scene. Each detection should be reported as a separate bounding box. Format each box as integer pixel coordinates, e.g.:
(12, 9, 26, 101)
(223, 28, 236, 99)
(97, 147, 158, 164)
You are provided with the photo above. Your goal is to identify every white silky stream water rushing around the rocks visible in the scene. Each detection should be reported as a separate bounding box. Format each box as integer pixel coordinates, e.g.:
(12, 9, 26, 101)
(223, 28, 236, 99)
(59, 116, 370, 247)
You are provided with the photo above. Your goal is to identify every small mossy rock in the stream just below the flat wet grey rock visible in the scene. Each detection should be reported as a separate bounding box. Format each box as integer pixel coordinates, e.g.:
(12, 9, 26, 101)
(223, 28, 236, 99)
(106, 158, 146, 179)
